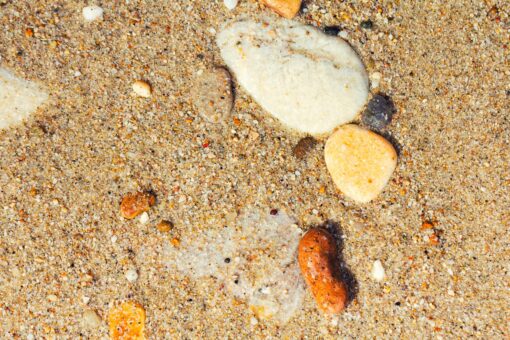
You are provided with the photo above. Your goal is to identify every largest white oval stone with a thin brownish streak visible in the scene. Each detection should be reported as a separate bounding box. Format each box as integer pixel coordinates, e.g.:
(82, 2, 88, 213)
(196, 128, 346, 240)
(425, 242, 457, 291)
(217, 19, 368, 135)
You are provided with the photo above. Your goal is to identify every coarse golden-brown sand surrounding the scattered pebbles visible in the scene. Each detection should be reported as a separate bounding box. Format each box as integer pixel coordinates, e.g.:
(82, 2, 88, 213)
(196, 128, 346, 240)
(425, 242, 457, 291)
(0, 0, 510, 339)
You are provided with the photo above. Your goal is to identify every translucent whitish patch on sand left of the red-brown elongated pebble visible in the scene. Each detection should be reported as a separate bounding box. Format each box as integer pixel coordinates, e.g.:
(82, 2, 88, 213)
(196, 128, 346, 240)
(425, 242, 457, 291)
(165, 211, 305, 323)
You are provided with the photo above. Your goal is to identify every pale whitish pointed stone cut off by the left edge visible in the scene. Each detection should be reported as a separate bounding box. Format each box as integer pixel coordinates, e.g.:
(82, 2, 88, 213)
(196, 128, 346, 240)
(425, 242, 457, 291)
(0, 68, 48, 129)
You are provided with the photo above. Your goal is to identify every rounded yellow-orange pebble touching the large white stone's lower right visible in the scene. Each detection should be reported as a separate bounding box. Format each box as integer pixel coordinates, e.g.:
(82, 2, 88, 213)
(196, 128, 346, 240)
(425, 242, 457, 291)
(324, 124, 397, 203)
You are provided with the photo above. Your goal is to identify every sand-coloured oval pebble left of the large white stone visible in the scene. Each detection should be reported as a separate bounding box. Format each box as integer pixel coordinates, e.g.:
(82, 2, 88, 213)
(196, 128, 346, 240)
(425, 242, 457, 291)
(192, 67, 234, 123)
